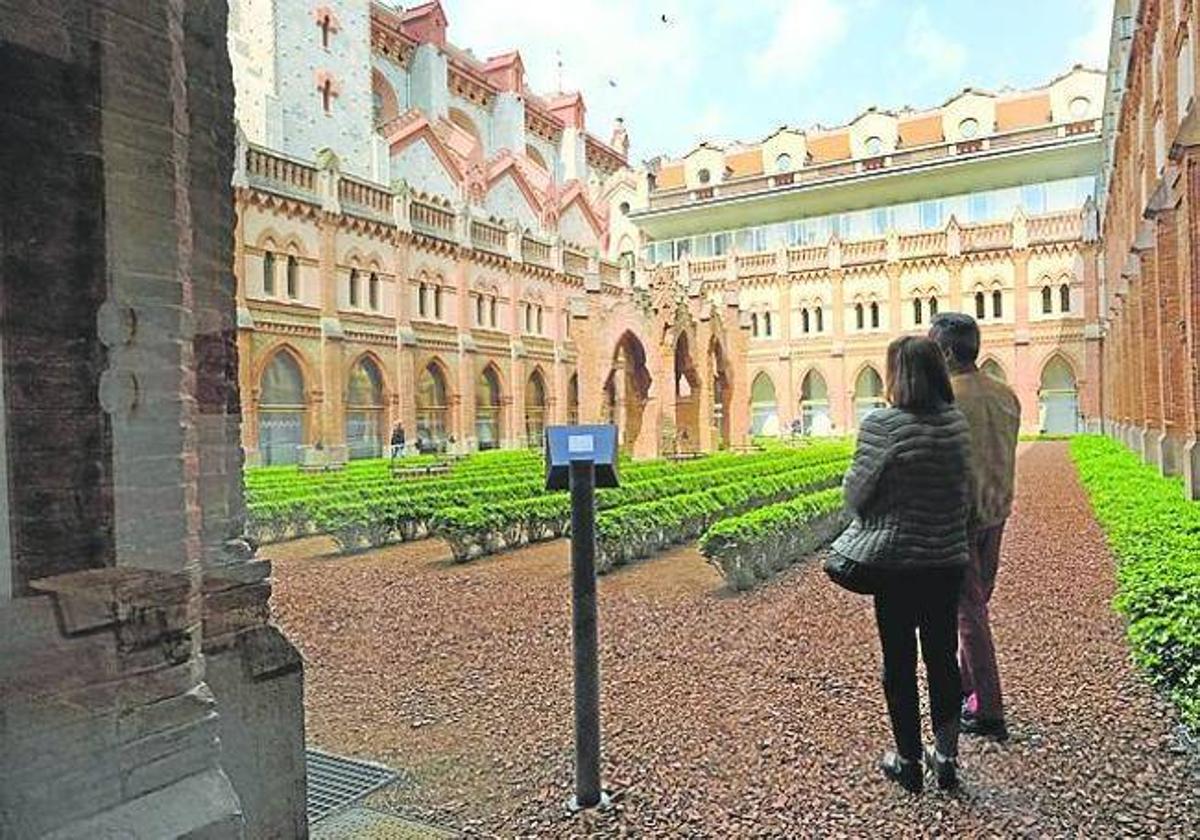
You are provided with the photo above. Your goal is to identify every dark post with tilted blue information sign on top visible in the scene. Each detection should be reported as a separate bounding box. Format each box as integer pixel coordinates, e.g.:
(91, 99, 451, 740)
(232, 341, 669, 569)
(546, 426, 617, 811)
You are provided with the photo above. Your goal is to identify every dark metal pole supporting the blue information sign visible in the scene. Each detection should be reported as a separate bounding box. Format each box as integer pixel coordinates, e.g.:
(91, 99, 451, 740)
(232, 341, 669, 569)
(571, 461, 601, 808)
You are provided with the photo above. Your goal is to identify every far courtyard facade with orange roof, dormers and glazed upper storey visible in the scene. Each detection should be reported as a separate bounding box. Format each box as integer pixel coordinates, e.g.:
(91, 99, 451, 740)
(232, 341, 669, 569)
(632, 67, 1104, 434)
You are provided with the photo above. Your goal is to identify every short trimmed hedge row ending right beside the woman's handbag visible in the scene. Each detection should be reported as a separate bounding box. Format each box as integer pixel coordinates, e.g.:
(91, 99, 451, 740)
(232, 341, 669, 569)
(700, 486, 846, 590)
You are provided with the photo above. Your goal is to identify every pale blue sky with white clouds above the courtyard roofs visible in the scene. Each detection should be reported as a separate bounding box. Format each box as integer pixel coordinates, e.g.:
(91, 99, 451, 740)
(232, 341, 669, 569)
(443, 0, 1112, 161)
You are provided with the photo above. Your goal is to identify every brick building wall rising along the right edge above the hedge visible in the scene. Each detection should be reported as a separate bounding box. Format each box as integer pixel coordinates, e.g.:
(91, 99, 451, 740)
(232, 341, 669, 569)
(1096, 0, 1200, 499)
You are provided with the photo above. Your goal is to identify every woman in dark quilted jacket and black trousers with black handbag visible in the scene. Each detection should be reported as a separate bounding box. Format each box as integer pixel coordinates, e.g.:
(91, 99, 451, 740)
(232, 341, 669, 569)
(826, 336, 971, 792)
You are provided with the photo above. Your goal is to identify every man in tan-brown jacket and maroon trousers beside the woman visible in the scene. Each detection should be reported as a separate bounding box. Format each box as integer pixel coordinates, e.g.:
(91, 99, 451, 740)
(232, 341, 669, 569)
(929, 312, 1021, 740)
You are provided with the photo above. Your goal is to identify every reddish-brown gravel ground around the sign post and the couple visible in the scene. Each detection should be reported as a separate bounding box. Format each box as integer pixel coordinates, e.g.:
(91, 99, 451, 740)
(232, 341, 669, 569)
(268, 443, 1200, 838)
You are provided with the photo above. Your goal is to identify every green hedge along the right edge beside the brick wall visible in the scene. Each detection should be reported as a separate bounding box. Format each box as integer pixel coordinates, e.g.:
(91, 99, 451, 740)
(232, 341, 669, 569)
(1070, 436, 1200, 727)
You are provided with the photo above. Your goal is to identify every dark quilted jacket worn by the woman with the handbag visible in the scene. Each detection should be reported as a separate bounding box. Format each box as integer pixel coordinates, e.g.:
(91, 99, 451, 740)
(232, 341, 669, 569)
(833, 406, 971, 569)
